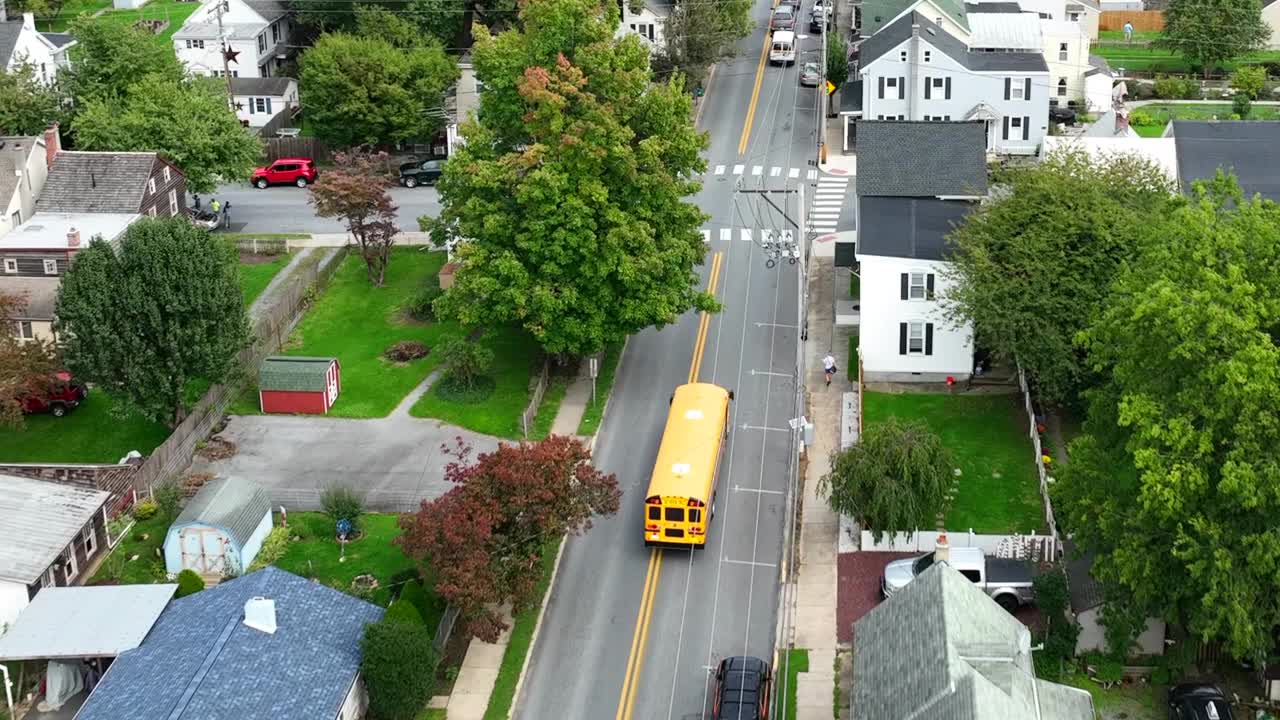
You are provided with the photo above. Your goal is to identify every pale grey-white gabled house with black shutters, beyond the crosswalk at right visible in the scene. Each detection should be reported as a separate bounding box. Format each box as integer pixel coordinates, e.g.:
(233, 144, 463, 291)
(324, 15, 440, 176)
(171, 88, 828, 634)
(858, 12, 1048, 155)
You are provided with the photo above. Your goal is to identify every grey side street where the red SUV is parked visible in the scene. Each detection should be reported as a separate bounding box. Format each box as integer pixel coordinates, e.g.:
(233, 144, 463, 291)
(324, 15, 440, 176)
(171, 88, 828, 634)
(200, 182, 440, 233)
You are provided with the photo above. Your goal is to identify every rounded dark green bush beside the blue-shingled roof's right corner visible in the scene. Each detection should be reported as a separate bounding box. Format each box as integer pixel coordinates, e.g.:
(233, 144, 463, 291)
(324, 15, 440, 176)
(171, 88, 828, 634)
(360, 618, 438, 720)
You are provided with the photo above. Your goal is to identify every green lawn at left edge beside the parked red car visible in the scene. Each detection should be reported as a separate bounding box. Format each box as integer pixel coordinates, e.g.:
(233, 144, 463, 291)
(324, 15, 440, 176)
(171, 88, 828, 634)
(0, 388, 169, 462)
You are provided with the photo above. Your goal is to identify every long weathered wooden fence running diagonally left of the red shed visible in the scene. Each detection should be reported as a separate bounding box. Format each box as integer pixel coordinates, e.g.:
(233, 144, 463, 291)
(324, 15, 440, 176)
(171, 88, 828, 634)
(133, 250, 346, 492)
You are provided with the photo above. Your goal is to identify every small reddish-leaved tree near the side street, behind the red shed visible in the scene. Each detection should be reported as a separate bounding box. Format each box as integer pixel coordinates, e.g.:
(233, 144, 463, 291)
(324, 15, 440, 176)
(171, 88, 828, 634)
(307, 150, 399, 287)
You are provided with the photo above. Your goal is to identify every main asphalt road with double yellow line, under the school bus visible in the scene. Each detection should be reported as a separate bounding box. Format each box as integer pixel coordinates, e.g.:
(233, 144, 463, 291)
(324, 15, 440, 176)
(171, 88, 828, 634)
(515, 0, 819, 720)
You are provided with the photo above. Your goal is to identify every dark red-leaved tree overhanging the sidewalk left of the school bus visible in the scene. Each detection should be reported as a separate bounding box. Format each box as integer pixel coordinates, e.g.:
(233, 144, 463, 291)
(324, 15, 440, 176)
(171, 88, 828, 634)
(396, 436, 622, 642)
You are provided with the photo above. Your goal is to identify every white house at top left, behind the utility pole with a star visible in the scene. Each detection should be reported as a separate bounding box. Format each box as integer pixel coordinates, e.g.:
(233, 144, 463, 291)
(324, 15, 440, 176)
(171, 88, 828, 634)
(173, 0, 291, 78)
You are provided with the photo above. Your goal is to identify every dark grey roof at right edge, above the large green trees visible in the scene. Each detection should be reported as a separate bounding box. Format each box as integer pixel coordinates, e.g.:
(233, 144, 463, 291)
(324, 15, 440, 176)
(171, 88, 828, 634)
(1174, 120, 1280, 202)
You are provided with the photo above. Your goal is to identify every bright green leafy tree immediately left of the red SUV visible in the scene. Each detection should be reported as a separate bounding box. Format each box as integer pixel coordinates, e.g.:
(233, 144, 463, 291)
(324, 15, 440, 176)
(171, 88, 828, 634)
(76, 74, 262, 192)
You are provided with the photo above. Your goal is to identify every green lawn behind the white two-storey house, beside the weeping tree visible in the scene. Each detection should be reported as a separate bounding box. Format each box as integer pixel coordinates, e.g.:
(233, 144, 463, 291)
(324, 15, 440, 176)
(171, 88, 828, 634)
(863, 392, 1044, 533)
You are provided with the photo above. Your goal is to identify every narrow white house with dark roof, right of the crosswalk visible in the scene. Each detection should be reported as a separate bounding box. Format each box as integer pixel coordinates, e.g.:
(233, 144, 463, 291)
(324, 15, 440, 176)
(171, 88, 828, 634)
(836, 120, 987, 382)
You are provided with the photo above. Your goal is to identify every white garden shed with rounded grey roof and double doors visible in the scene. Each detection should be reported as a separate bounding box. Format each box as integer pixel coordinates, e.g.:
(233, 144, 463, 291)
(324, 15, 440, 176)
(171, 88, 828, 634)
(164, 478, 271, 575)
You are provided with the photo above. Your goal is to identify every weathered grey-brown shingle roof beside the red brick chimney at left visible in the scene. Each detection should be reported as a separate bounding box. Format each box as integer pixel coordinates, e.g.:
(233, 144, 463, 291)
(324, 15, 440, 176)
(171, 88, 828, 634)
(36, 151, 161, 213)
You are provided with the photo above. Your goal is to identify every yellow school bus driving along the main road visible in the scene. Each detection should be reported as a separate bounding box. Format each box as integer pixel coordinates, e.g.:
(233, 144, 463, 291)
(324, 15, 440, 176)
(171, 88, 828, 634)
(644, 383, 733, 548)
